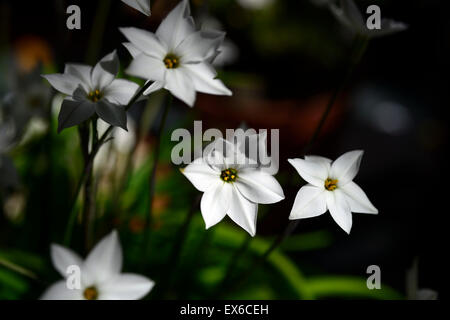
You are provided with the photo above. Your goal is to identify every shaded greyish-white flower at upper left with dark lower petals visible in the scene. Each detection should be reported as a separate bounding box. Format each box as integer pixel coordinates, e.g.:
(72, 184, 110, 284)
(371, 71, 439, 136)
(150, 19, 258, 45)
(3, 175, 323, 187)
(43, 51, 139, 131)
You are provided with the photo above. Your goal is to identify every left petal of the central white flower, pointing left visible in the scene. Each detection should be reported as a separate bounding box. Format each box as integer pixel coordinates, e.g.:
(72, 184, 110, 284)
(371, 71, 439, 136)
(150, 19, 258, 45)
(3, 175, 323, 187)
(181, 157, 220, 192)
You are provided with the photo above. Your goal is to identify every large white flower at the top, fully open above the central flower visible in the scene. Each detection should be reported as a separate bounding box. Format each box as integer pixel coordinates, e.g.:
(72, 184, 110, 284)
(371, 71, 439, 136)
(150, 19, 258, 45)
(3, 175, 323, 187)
(120, 0, 231, 107)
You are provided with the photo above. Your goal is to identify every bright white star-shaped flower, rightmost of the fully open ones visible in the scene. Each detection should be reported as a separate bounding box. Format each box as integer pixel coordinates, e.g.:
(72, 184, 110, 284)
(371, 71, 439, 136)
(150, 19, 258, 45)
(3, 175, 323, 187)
(288, 150, 378, 233)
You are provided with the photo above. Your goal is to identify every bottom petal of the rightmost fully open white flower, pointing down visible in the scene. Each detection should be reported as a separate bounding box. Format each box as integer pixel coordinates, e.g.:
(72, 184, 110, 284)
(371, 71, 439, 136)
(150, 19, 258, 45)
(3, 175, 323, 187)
(326, 189, 352, 234)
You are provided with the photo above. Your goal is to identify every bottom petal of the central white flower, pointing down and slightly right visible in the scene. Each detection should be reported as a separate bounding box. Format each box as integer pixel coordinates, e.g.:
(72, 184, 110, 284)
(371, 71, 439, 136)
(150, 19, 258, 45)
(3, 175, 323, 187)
(227, 188, 258, 237)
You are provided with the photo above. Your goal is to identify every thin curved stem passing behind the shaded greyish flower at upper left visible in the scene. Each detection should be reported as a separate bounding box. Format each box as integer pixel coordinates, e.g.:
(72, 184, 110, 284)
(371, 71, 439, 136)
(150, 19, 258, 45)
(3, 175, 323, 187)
(63, 81, 152, 246)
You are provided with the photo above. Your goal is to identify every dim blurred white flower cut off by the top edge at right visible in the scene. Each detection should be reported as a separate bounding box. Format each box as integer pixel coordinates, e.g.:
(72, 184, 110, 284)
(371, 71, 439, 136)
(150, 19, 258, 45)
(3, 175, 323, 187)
(328, 0, 408, 37)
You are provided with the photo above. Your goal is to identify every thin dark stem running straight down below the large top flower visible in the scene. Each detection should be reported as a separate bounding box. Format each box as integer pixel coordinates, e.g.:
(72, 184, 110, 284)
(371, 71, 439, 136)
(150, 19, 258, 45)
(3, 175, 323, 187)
(142, 93, 173, 266)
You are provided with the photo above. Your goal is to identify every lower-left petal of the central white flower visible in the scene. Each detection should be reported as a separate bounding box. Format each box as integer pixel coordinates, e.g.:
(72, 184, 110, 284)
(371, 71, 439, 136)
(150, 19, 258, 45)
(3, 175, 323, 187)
(200, 180, 233, 229)
